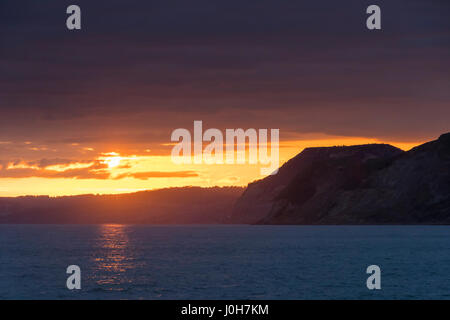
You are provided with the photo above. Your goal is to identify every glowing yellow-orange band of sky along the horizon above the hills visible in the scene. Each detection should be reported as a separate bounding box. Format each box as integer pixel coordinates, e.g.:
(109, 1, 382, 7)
(0, 135, 420, 196)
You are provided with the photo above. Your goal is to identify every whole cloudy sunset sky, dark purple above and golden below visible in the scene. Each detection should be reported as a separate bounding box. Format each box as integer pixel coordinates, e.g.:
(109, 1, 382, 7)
(0, 0, 450, 196)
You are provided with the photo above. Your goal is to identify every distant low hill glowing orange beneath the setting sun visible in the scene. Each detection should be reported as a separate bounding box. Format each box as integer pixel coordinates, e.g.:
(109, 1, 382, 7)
(0, 187, 243, 224)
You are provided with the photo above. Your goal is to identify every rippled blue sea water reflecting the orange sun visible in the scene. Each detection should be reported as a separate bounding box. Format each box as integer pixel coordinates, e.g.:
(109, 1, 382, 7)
(0, 225, 450, 299)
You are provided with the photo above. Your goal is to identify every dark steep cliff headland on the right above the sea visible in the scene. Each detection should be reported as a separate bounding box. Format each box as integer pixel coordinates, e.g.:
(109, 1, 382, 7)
(232, 134, 450, 224)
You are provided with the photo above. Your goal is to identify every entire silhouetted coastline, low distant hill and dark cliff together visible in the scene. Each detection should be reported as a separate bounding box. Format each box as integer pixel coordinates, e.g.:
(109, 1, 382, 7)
(0, 133, 450, 224)
